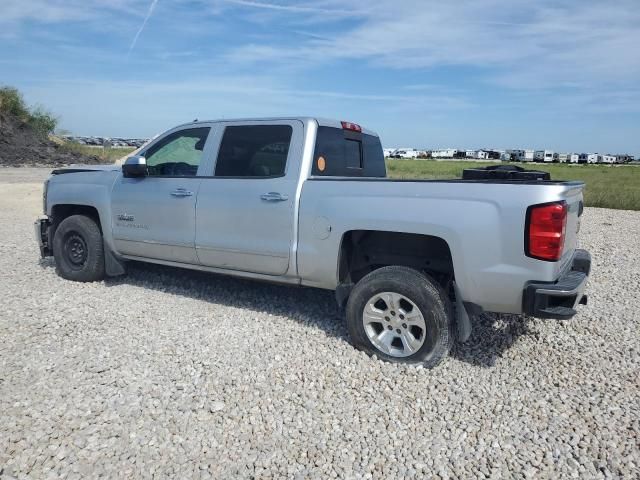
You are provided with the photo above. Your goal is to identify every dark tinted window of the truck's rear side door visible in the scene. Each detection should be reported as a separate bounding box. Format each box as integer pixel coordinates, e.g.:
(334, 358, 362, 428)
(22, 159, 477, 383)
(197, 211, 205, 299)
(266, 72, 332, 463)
(215, 125, 293, 178)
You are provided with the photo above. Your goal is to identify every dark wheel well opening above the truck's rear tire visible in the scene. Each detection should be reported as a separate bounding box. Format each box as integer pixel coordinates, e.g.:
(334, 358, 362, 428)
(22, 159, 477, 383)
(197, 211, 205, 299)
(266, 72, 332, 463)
(338, 230, 454, 289)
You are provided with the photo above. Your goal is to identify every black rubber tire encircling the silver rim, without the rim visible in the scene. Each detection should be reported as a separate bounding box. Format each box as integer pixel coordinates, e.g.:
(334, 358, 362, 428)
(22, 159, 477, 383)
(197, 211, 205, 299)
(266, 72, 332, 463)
(346, 266, 455, 368)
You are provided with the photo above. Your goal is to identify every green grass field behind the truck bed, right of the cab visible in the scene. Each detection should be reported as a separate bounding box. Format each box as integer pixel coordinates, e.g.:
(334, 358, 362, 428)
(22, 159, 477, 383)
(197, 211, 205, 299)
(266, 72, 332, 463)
(387, 159, 640, 210)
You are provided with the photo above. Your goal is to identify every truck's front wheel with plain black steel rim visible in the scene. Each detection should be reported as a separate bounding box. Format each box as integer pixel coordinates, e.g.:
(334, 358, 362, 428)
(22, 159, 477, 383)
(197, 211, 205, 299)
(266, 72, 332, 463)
(53, 215, 104, 282)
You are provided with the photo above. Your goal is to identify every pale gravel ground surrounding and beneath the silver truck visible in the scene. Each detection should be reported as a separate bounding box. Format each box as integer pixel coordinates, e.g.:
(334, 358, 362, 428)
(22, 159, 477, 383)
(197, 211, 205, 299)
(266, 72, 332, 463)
(0, 169, 640, 478)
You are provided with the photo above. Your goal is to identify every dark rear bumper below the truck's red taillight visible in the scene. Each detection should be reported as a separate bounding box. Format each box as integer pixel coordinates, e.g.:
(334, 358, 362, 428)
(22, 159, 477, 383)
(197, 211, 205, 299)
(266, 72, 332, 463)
(522, 250, 591, 320)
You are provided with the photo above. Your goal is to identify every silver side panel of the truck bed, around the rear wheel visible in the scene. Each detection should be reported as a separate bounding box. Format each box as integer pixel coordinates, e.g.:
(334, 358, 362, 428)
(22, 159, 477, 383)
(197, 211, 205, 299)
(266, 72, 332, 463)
(298, 177, 584, 313)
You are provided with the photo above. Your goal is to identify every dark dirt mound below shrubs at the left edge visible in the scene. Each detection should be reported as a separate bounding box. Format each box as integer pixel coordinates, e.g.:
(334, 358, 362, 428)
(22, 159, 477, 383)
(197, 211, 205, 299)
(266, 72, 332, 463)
(0, 111, 103, 167)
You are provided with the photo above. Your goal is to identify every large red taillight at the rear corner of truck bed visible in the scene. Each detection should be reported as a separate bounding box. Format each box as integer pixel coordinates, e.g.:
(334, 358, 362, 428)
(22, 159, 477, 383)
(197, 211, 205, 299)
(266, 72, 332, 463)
(526, 202, 567, 262)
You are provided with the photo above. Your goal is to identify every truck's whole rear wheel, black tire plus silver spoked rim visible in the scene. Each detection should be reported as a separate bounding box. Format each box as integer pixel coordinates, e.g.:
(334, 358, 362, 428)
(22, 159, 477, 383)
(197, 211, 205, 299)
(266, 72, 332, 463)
(346, 266, 454, 368)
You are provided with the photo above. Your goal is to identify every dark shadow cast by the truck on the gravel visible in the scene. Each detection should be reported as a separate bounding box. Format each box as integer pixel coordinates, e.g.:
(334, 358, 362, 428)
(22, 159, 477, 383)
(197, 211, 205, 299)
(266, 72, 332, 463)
(40, 258, 535, 368)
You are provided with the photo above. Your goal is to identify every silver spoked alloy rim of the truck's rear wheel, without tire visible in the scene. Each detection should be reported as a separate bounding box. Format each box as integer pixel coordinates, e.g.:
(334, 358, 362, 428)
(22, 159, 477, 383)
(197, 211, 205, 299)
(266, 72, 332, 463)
(362, 292, 427, 358)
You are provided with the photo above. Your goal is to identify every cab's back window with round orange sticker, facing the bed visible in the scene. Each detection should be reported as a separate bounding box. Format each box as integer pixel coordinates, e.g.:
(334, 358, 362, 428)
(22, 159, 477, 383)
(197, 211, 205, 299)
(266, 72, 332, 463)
(312, 127, 386, 177)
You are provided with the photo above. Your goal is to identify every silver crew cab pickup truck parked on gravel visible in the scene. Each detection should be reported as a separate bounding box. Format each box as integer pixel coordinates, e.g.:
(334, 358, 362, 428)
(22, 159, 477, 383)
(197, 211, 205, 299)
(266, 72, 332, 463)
(35, 117, 591, 367)
